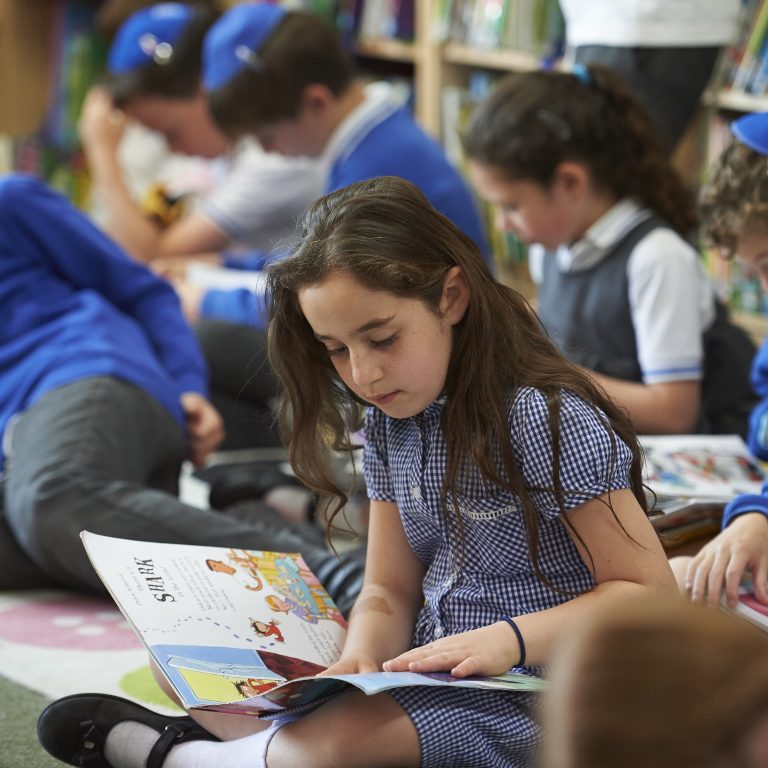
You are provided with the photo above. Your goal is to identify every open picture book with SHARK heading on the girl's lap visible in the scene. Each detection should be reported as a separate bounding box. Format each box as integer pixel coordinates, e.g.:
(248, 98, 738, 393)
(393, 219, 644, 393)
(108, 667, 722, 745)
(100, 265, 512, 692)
(81, 531, 544, 717)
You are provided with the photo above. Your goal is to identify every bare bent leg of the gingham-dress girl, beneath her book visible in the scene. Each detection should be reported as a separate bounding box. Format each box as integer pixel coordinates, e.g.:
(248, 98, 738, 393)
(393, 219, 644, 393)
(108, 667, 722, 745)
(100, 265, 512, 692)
(266, 691, 421, 768)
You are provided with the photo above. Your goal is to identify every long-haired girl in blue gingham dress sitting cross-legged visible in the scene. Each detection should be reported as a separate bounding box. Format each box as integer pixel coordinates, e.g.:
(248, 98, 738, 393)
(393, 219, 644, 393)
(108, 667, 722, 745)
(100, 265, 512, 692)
(40, 177, 675, 768)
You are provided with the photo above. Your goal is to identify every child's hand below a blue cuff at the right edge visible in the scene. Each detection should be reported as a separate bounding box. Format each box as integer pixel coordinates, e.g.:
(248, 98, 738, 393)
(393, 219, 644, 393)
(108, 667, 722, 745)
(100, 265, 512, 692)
(685, 512, 768, 608)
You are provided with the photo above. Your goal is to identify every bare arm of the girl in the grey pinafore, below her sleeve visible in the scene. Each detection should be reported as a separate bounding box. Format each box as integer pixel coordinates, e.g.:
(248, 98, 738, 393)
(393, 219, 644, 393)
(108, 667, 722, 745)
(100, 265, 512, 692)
(587, 370, 701, 435)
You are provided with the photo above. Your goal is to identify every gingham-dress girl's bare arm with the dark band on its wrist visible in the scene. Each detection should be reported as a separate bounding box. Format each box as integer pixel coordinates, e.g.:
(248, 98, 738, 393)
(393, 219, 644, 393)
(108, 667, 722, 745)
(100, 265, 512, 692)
(384, 489, 677, 677)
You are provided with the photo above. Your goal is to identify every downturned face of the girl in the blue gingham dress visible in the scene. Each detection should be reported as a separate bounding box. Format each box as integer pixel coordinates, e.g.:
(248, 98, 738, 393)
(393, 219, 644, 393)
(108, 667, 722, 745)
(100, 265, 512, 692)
(299, 267, 468, 419)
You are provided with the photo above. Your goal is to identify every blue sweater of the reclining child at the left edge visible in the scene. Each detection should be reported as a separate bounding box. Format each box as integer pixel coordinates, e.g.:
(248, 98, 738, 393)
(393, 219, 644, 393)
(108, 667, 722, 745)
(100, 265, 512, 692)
(0, 174, 207, 467)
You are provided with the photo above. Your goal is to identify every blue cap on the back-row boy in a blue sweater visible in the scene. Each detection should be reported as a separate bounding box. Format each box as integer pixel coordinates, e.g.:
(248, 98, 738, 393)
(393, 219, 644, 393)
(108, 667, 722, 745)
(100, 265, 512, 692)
(203, 3, 287, 91)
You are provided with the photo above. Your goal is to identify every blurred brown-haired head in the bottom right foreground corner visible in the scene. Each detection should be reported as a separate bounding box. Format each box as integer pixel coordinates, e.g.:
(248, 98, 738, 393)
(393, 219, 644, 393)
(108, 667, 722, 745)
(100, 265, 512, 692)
(539, 599, 768, 768)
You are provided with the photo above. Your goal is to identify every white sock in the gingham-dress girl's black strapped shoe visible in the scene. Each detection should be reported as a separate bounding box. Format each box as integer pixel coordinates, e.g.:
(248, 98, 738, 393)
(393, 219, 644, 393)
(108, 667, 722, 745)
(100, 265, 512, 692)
(104, 718, 295, 768)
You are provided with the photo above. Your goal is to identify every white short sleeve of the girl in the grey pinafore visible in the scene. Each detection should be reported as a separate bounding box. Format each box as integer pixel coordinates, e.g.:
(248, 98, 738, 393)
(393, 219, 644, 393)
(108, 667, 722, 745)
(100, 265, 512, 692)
(627, 229, 715, 384)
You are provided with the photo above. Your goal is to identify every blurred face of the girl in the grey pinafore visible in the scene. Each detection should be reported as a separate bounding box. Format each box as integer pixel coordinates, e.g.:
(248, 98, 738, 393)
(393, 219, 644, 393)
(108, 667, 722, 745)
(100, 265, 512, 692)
(469, 163, 588, 250)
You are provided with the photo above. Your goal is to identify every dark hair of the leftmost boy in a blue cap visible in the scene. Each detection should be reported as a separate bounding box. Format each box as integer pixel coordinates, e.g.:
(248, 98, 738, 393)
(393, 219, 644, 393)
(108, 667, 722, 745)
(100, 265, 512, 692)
(104, 3, 219, 109)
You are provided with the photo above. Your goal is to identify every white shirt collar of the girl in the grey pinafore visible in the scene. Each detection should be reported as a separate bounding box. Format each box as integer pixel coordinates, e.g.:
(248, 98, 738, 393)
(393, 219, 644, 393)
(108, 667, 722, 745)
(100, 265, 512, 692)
(556, 198, 652, 272)
